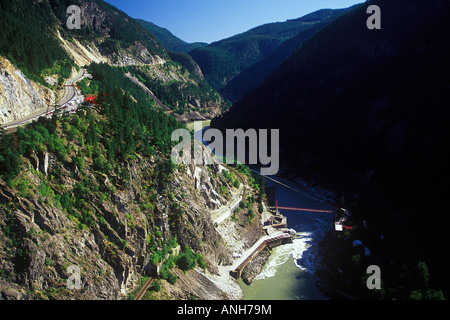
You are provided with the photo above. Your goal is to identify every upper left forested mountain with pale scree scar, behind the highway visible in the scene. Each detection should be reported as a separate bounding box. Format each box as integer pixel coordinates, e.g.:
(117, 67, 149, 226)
(0, 0, 223, 123)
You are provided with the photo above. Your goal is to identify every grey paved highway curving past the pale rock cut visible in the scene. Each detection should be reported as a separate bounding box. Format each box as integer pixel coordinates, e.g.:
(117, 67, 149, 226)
(3, 68, 86, 129)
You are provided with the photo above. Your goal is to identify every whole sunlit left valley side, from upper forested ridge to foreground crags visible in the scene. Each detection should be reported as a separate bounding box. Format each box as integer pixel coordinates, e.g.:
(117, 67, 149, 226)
(0, 0, 263, 299)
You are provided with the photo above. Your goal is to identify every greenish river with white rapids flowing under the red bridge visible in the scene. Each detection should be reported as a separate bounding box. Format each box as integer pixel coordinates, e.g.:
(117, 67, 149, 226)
(239, 178, 334, 300)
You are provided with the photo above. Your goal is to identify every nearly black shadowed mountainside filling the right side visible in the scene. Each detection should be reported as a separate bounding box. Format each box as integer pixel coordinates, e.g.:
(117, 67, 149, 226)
(212, 0, 450, 298)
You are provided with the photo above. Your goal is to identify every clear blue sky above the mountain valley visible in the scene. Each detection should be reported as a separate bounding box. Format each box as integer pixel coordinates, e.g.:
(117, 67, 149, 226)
(106, 0, 364, 43)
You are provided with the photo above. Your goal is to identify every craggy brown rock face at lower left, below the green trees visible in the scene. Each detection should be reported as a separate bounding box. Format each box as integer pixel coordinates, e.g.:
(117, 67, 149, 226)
(0, 141, 246, 299)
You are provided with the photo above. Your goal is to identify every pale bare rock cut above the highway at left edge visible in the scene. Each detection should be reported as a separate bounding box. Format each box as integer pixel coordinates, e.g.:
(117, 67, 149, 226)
(0, 56, 55, 125)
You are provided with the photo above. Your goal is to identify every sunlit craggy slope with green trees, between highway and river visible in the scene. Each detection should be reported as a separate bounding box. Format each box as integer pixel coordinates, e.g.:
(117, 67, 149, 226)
(0, 64, 243, 299)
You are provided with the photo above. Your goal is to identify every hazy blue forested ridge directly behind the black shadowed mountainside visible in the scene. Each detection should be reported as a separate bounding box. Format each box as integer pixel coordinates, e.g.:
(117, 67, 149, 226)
(189, 10, 350, 90)
